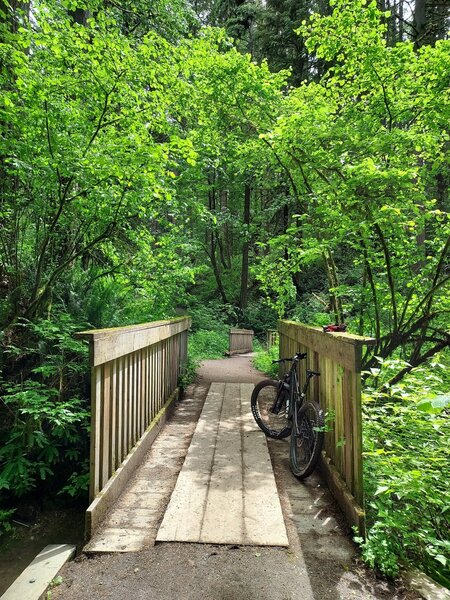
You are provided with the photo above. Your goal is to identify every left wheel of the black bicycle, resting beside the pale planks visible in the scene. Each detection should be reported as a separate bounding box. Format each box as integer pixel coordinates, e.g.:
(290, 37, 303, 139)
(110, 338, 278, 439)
(250, 379, 291, 439)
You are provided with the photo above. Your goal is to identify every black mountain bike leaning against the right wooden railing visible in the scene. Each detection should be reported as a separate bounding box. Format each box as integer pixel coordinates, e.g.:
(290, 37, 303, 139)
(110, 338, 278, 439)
(251, 352, 325, 479)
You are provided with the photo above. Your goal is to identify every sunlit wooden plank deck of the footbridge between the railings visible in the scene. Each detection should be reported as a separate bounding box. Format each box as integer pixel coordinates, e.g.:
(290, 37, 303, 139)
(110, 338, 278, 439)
(85, 383, 288, 552)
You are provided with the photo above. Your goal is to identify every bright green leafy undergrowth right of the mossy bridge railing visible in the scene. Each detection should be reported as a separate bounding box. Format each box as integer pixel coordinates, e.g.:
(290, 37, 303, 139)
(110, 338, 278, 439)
(357, 358, 450, 587)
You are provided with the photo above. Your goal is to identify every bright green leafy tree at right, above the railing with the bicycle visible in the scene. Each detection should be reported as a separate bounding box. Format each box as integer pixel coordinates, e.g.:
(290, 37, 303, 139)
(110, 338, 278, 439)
(256, 2, 450, 377)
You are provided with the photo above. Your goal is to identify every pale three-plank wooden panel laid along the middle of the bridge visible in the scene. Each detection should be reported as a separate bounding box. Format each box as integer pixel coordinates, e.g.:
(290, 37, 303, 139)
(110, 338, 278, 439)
(156, 383, 288, 546)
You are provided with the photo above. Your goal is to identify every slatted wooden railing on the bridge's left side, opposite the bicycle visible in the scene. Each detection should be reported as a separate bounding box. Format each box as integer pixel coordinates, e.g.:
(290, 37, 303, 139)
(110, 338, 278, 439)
(77, 317, 190, 537)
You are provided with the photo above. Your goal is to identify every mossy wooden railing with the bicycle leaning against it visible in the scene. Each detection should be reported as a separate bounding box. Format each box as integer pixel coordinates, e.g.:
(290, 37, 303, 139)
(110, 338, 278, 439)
(278, 321, 375, 531)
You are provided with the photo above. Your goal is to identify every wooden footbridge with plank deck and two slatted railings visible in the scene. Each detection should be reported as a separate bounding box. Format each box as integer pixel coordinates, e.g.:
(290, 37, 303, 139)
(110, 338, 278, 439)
(78, 317, 373, 552)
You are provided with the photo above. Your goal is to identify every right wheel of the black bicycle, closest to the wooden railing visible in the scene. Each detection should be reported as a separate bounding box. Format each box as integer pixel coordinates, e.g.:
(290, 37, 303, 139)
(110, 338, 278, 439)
(289, 401, 325, 479)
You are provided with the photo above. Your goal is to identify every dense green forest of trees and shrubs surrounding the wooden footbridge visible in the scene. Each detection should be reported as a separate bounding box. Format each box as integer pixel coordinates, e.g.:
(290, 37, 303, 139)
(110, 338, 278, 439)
(0, 0, 450, 587)
